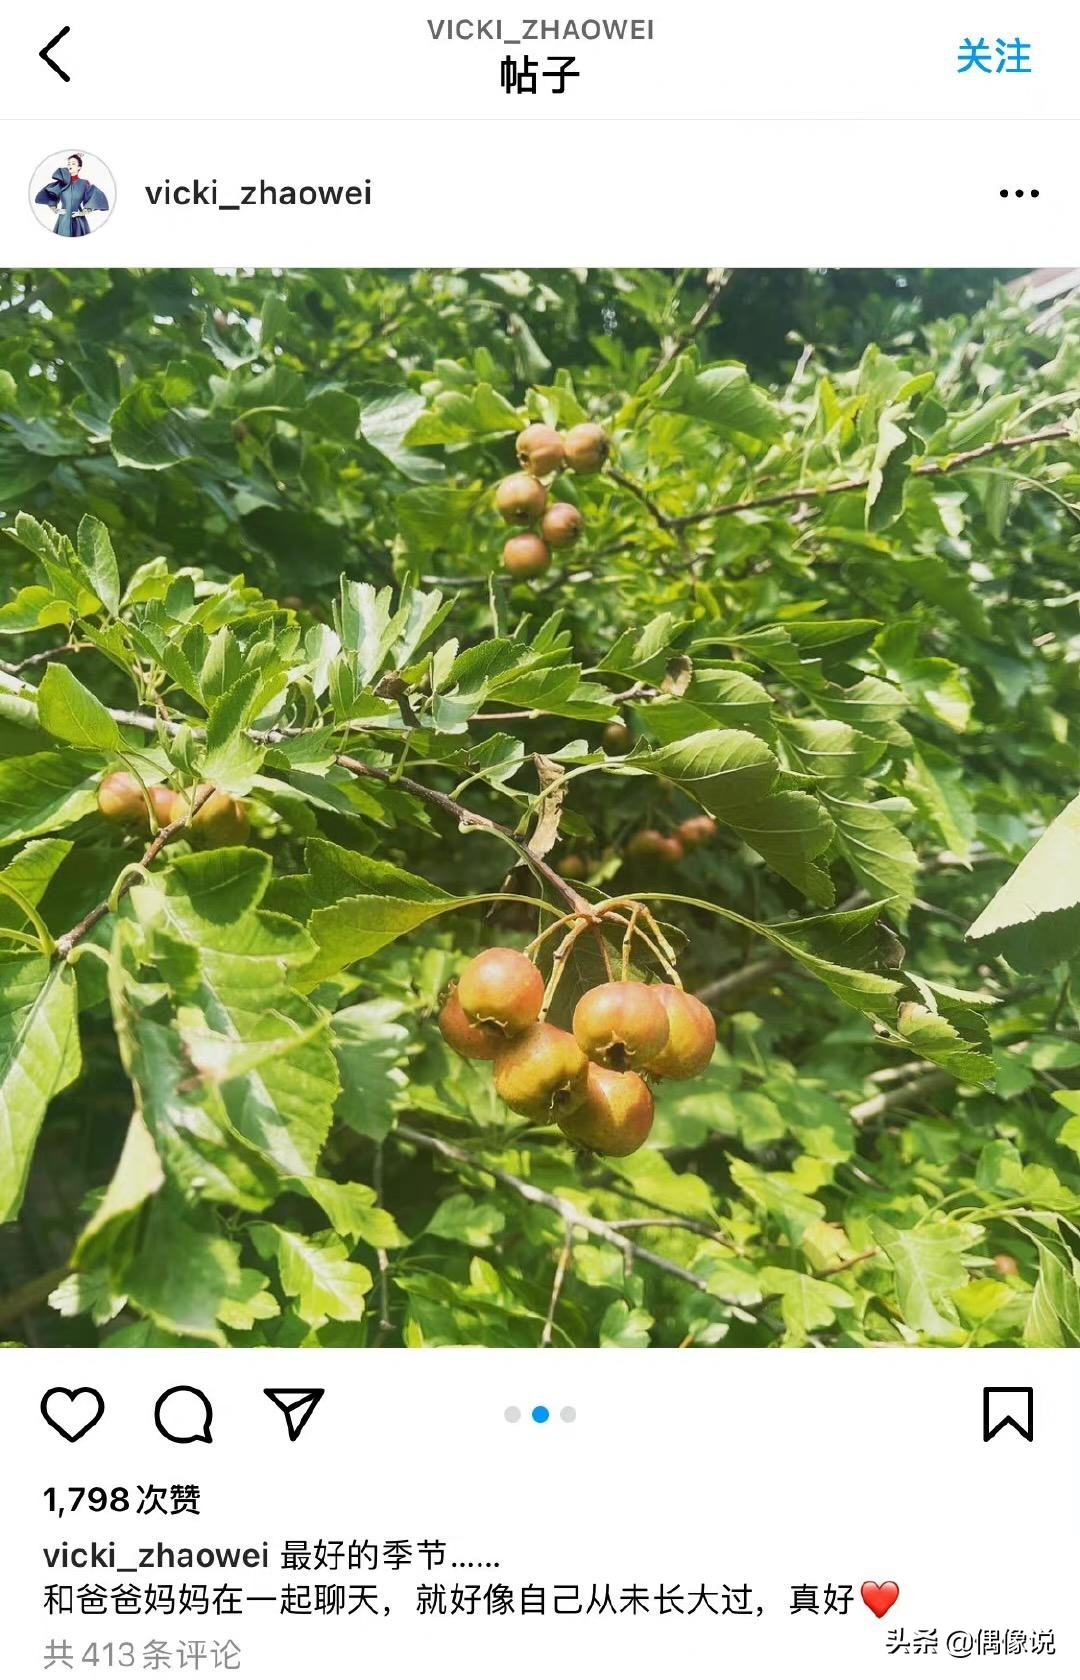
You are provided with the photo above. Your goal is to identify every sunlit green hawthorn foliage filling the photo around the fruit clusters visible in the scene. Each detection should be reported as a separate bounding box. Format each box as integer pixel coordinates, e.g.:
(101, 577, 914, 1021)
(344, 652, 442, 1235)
(0, 270, 1080, 1346)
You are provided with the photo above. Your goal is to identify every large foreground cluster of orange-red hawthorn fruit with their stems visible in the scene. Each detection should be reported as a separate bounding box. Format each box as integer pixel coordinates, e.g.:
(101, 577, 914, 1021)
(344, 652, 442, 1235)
(438, 900, 716, 1156)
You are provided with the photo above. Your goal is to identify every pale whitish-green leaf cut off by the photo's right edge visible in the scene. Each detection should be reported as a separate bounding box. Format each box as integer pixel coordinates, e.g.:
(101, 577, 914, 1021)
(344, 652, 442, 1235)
(967, 798, 1080, 974)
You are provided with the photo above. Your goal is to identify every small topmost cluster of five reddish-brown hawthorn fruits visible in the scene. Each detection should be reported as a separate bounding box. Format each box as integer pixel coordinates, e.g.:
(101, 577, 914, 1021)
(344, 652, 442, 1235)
(495, 422, 610, 578)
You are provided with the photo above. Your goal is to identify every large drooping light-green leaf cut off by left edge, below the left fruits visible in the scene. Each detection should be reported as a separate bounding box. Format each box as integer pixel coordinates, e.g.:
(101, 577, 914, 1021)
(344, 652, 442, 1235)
(0, 956, 82, 1225)
